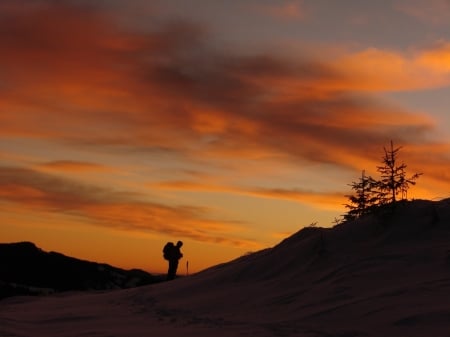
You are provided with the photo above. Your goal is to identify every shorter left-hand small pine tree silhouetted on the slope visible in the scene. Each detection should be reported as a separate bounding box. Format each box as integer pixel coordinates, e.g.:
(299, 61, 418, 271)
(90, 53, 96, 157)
(344, 170, 379, 220)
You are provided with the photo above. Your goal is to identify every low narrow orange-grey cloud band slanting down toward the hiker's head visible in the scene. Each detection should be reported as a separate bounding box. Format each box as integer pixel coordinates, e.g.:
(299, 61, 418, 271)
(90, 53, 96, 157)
(0, 167, 256, 246)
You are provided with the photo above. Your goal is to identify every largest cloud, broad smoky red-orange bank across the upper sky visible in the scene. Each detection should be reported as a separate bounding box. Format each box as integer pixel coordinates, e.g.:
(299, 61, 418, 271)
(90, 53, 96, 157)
(0, 0, 442, 161)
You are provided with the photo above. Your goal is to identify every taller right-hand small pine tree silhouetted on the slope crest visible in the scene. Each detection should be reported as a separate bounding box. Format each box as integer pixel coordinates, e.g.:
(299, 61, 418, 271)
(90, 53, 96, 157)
(377, 140, 422, 204)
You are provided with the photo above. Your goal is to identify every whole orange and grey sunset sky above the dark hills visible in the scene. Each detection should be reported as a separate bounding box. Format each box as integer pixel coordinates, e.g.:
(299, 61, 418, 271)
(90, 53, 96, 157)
(0, 0, 450, 273)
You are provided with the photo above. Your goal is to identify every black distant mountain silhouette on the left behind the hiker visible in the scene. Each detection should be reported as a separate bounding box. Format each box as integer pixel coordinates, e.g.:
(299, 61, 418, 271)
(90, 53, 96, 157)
(0, 242, 162, 299)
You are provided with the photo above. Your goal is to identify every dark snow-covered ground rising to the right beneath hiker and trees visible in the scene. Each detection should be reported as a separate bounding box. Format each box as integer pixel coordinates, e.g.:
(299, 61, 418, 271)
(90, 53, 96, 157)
(0, 199, 450, 337)
